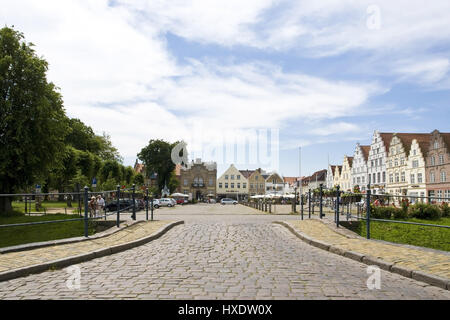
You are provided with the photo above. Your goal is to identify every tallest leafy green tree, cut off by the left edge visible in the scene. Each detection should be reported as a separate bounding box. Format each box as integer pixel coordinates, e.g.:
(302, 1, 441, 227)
(0, 27, 68, 214)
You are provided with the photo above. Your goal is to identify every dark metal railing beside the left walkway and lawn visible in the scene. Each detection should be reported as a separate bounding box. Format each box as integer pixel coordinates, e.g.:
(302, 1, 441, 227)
(0, 185, 154, 237)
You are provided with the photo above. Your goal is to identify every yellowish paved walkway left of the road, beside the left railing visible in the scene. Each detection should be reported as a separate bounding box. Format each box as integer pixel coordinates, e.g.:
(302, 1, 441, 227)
(0, 221, 169, 272)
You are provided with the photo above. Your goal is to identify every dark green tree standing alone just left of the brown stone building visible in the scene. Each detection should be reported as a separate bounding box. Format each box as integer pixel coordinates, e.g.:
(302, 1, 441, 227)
(138, 139, 178, 190)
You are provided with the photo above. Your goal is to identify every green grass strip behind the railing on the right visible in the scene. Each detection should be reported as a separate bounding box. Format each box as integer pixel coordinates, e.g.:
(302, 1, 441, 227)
(347, 217, 450, 251)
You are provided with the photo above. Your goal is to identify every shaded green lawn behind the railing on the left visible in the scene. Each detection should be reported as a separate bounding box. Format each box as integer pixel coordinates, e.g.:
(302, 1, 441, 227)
(0, 214, 95, 248)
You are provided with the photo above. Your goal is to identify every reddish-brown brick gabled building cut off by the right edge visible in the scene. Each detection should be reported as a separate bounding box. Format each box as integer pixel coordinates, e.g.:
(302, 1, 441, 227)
(426, 130, 450, 202)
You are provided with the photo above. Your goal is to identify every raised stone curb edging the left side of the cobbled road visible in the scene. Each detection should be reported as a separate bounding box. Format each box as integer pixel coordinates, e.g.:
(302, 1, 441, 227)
(0, 221, 184, 282)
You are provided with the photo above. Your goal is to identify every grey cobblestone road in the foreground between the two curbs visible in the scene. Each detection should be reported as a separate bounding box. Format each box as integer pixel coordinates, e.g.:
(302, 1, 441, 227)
(0, 209, 450, 299)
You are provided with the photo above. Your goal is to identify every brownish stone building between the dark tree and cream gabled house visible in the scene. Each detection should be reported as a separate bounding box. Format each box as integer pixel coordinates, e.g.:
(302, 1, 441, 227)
(179, 159, 217, 201)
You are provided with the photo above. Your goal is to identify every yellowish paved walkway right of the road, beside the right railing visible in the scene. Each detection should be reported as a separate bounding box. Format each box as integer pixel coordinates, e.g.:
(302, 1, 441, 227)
(289, 219, 450, 279)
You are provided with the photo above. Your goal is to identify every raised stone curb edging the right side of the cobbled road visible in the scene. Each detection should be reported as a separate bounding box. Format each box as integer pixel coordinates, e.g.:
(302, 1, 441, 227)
(273, 221, 450, 290)
